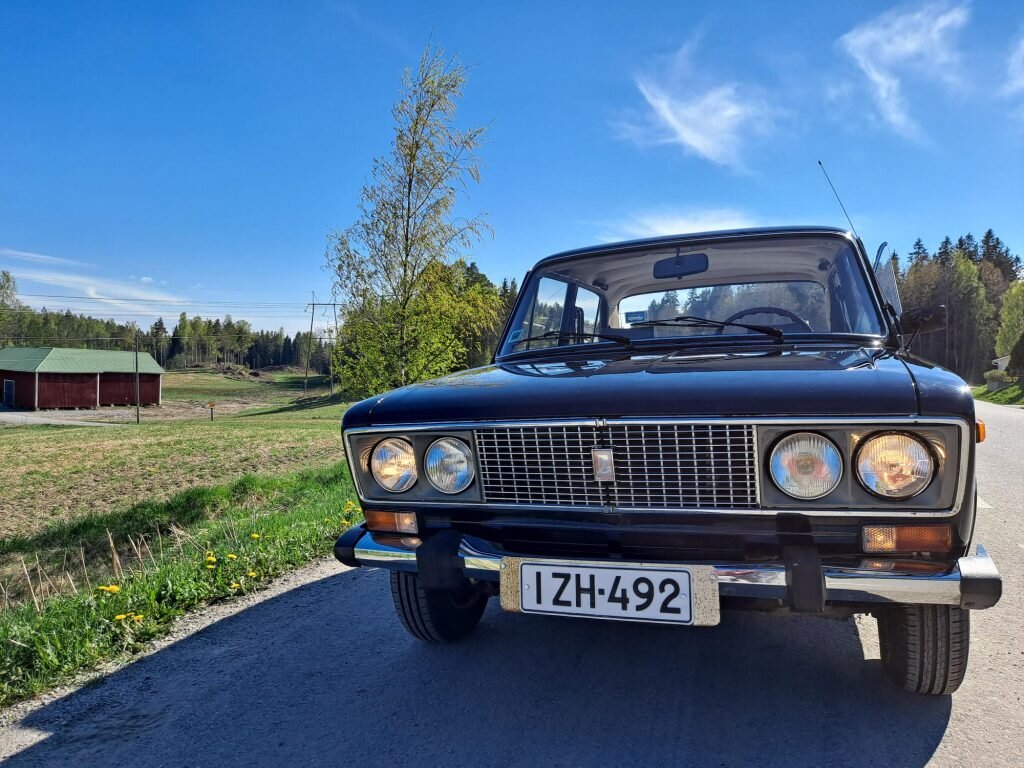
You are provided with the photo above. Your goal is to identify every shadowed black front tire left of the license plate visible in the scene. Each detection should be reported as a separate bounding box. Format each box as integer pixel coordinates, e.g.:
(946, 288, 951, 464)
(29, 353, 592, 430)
(391, 570, 487, 643)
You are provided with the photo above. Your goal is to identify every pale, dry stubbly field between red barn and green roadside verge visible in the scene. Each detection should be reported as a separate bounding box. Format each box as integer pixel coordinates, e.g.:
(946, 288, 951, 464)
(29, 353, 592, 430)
(0, 373, 345, 540)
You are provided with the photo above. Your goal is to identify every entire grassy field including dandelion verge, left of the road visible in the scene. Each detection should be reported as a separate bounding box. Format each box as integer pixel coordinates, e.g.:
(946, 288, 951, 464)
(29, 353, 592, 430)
(0, 372, 360, 705)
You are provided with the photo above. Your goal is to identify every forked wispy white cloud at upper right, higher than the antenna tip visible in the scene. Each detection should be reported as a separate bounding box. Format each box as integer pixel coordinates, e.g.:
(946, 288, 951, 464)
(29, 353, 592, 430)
(839, 2, 970, 138)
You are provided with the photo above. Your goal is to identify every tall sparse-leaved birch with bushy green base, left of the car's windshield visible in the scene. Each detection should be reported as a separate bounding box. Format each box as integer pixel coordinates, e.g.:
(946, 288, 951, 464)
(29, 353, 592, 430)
(329, 47, 503, 396)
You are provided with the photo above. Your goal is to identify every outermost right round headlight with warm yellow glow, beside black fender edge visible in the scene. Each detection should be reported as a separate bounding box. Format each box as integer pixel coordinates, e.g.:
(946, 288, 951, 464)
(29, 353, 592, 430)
(857, 432, 935, 499)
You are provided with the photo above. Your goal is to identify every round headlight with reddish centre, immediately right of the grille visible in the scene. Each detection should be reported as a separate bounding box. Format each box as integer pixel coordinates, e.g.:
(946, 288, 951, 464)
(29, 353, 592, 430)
(770, 432, 843, 499)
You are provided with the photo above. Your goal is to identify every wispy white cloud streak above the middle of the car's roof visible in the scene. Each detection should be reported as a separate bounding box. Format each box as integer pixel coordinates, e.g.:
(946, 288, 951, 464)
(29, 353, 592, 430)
(620, 42, 779, 169)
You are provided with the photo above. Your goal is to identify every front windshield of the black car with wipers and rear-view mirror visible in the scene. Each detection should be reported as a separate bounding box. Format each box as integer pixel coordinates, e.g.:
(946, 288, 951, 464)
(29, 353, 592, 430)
(500, 234, 885, 355)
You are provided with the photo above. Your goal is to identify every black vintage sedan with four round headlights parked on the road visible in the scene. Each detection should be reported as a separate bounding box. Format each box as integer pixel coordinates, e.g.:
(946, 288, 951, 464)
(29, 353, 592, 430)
(335, 227, 1001, 694)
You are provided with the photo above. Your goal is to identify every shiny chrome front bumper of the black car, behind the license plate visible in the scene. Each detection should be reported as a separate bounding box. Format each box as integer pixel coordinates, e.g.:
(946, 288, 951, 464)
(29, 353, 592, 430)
(335, 529, 1002, 608)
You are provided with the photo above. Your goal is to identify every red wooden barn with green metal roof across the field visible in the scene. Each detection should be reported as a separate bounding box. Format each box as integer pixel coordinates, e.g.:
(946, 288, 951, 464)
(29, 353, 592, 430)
(0, 347, 164, 411)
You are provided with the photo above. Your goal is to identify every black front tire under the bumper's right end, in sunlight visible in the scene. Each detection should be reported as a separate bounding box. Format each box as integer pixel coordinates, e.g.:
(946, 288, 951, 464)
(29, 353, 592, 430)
(877, 605, 971, 695)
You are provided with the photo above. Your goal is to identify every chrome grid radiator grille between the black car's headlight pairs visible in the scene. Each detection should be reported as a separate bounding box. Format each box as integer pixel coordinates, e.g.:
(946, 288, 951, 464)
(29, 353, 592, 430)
(476, 422, 758, 510)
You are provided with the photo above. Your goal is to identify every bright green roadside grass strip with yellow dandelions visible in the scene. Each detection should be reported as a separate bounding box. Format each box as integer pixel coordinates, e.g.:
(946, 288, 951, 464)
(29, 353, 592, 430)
(0, 464, 359, 706)
